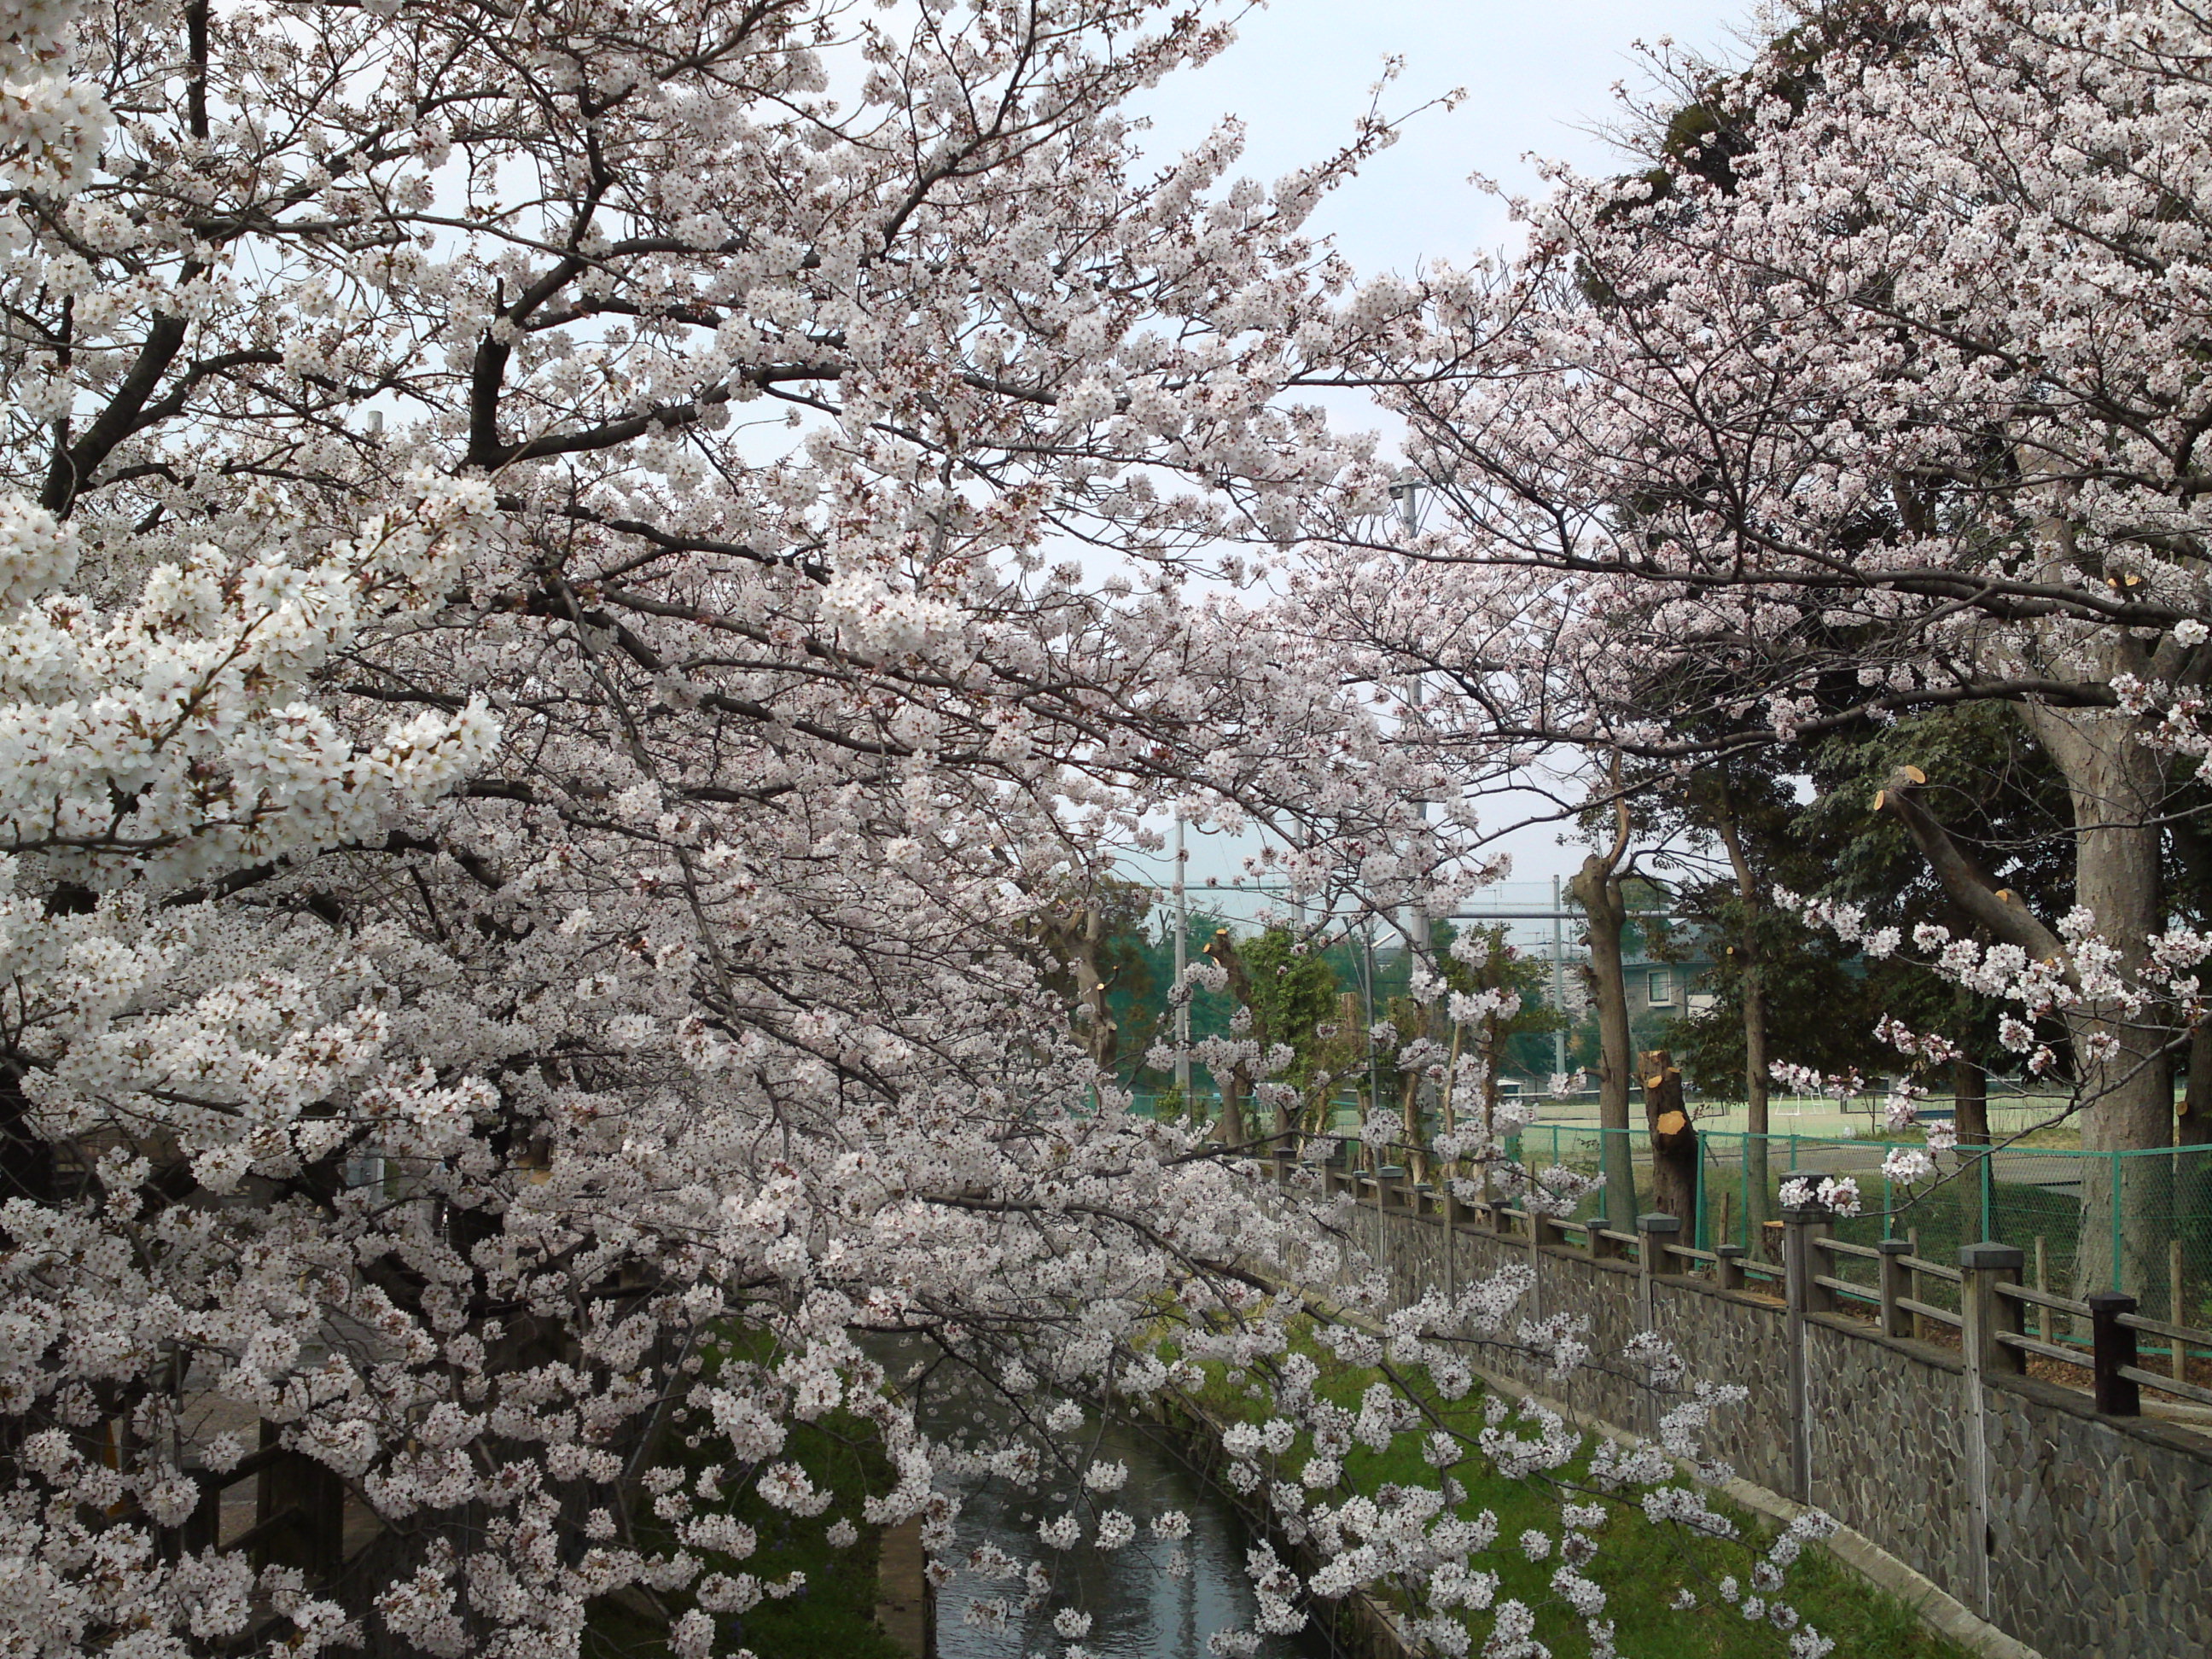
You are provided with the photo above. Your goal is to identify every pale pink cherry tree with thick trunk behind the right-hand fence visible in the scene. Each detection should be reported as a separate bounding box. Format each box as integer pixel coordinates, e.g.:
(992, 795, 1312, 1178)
(1316, 0, 2212, 1212)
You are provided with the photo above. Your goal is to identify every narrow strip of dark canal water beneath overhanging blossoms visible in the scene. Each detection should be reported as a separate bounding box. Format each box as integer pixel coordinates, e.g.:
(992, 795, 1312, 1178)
(920, 1417, 1330, 1659)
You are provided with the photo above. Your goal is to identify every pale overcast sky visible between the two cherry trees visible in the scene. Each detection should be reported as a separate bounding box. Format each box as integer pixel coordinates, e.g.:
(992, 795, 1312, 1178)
(1115, 0, 1752, 903)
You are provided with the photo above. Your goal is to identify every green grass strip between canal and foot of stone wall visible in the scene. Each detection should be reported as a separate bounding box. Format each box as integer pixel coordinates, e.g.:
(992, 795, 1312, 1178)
(1203, 1345, 1966, 1659)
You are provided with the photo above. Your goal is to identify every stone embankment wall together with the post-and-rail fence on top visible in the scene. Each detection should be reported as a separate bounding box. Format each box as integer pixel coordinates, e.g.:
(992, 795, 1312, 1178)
(1277, 1155, 2212, 1659)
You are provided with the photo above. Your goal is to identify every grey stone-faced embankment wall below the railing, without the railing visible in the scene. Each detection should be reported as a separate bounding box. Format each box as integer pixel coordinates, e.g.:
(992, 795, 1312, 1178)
(1309, 1184, 2212, 1659)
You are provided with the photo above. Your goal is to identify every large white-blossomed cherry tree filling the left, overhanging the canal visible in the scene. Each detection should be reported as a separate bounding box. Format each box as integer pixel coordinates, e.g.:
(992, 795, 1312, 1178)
(0, 0, 1819, 1659)
